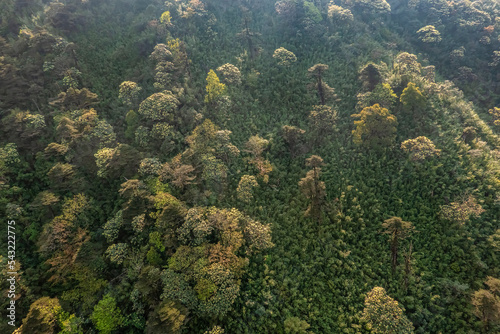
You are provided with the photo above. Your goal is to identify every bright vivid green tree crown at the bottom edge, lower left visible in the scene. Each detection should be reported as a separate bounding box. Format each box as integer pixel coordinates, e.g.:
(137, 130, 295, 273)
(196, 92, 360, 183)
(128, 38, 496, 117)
(91, 294, 125, 334)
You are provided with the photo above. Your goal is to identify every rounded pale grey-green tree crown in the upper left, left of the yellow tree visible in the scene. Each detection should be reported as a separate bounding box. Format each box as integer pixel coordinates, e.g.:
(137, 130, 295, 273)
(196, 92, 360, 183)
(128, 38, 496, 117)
(139, 91, 180, 122)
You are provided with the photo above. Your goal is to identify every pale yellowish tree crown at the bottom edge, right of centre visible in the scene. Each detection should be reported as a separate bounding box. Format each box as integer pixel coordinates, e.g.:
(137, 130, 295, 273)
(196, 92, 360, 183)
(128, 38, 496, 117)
(361, 287, 413, 334)
